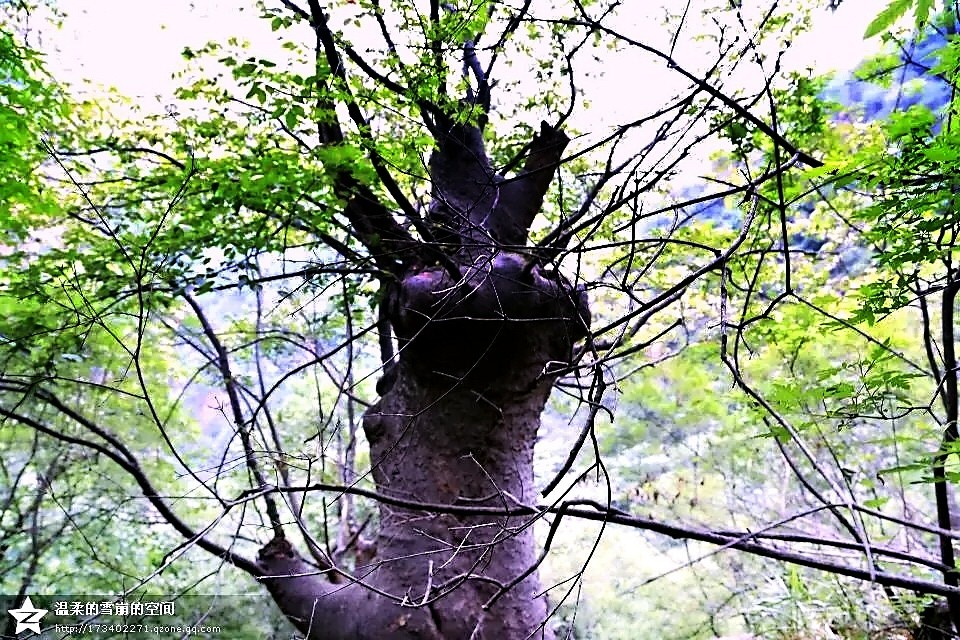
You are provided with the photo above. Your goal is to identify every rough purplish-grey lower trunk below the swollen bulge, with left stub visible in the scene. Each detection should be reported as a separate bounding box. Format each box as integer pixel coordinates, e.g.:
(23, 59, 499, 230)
(260, 323, 576, 640)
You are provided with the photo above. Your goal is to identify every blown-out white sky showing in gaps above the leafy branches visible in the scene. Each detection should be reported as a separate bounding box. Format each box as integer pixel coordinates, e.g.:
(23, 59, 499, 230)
(42, 0, 882, 113)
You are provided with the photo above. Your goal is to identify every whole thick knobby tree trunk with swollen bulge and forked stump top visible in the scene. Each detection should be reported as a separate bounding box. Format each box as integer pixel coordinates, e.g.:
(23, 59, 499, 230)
(258, 119, 589, 640)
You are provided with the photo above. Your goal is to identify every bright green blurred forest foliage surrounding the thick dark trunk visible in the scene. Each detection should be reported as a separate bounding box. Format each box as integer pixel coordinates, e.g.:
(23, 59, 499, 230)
(0, 0, 960, 640)
